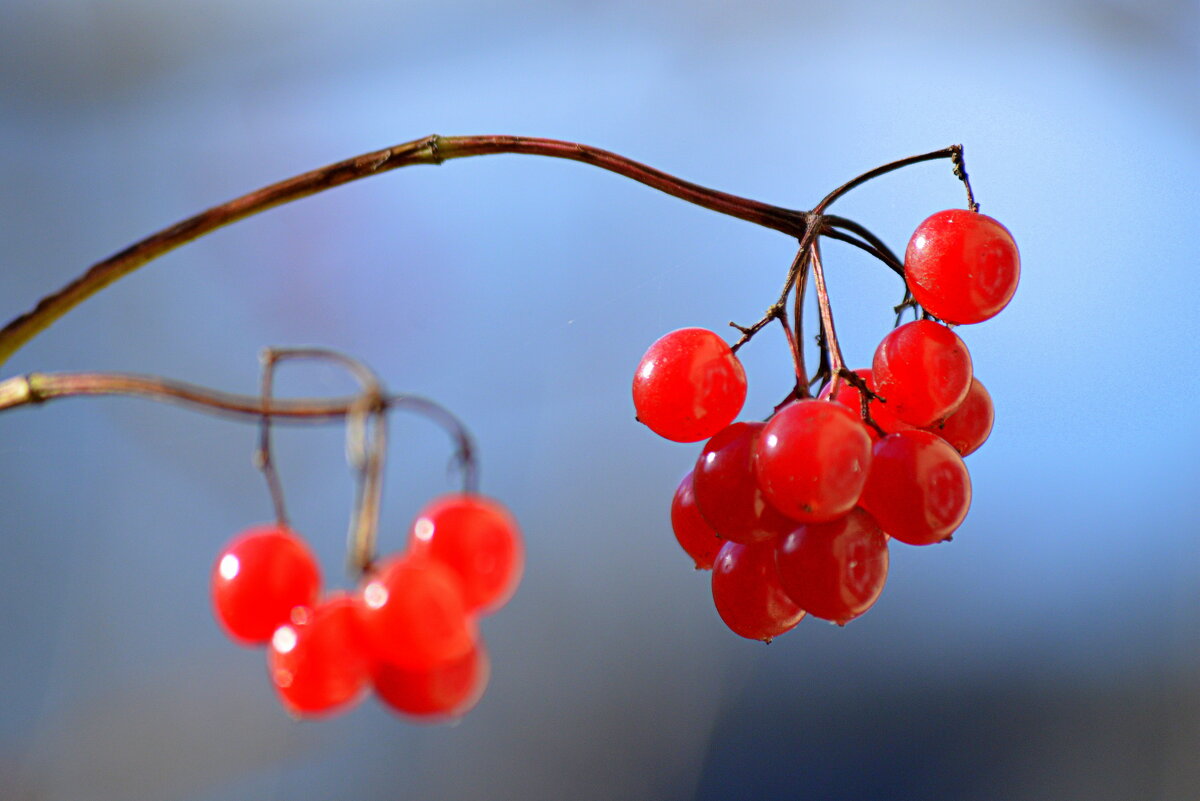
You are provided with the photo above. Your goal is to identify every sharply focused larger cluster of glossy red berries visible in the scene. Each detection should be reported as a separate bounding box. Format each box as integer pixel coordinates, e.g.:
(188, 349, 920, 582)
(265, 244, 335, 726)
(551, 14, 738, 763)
(634, 210, 1020, 640)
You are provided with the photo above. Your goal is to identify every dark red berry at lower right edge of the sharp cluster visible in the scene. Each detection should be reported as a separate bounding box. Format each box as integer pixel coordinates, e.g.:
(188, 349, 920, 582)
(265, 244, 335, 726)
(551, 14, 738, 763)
(862, 430, 971, 546)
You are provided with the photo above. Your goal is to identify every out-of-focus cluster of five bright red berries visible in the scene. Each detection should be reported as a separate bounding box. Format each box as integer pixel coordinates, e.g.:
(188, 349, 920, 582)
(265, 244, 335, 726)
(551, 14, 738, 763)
(212, 493, 524, 719)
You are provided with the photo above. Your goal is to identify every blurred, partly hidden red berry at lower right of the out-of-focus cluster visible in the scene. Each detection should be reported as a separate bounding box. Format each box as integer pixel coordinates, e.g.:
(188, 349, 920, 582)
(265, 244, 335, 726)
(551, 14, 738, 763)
(374, 643, 491, 722)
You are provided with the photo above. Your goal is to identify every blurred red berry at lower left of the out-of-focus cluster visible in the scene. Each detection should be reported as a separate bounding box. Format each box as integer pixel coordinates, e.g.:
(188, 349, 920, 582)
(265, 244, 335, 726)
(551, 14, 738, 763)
(266, 594, 371, 715)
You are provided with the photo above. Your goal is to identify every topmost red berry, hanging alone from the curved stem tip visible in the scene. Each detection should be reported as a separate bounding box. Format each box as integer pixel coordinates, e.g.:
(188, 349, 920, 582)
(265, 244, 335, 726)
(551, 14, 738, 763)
(905, 209, 1021, 324)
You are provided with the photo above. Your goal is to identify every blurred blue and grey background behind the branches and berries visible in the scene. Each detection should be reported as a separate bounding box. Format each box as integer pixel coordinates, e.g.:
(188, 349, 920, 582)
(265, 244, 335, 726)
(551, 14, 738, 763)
(0, 0, 1200, 801)
